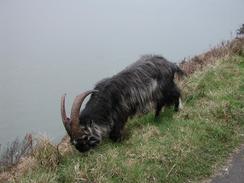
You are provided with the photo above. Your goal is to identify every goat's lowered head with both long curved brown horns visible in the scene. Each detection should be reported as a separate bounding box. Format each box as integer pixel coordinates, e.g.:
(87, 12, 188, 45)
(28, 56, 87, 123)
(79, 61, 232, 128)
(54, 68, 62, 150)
(61, 90, 100, 152)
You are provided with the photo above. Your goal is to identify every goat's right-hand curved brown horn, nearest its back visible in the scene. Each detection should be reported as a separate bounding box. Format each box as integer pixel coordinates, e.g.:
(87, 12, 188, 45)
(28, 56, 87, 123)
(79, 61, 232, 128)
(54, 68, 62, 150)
(70, 90, 97, 137)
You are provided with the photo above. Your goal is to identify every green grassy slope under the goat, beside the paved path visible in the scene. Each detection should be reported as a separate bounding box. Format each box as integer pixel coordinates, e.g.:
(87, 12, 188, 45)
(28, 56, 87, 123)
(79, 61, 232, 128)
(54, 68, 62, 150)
(19, 57, 244, 183)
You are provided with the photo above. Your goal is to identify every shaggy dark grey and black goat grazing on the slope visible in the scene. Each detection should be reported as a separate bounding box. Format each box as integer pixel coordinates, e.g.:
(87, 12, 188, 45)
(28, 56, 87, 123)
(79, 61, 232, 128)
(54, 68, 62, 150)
(61, 56, 183, 152)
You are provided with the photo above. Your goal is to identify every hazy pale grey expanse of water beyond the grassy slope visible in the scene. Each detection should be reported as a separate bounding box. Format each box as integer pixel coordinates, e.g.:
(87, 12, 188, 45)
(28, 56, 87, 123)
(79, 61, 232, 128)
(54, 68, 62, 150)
(0, 0, 244, 144)
